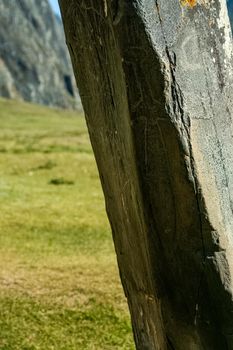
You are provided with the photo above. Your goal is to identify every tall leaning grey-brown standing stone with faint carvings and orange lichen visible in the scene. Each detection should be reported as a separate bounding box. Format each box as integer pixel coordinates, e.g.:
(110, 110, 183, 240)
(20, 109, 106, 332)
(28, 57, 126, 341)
(60, 0, 233, 350)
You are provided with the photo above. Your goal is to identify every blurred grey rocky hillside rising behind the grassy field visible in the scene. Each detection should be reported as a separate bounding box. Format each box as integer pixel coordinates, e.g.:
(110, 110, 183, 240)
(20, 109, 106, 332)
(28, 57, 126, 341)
(0, 0, 80, 107)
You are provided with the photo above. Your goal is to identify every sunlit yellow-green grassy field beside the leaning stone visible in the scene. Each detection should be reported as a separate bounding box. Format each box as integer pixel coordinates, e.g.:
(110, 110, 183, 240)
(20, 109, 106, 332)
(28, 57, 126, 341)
(0, 99, 134, 350)
